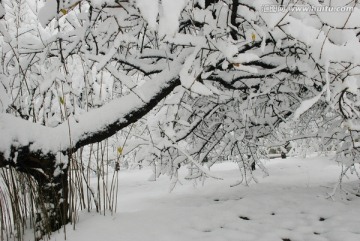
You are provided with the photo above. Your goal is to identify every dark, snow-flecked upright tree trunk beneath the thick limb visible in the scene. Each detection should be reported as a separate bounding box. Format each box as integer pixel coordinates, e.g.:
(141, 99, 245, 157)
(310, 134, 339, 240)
(17, 149, 69, 240)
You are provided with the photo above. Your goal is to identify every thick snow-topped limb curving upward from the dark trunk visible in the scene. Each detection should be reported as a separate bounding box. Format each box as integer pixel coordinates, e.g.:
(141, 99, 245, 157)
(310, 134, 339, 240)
(0, 51, 187, 168)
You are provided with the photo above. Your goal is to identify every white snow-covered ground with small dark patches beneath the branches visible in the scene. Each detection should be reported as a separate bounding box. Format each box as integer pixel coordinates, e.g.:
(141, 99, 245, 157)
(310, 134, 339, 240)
(51, 157, 360, 241)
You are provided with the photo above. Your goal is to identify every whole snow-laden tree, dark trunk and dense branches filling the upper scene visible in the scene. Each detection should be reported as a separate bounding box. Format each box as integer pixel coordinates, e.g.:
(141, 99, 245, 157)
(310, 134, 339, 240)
(0, 0, 360, 237)
